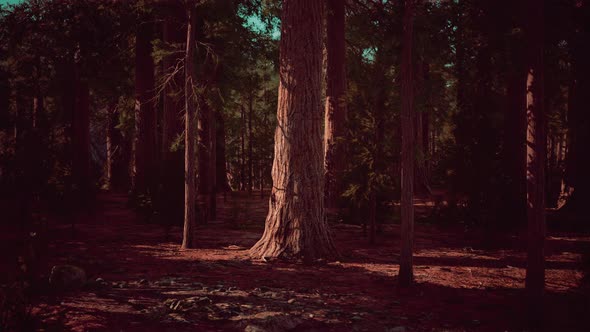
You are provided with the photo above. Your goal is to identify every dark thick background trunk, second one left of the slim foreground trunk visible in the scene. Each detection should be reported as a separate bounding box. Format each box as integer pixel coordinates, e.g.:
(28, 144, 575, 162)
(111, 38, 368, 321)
(133, 22, 158, 194)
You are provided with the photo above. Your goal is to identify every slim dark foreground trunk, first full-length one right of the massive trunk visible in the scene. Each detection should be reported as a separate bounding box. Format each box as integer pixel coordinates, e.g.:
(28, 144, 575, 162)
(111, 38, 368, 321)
(399, 0, 415, 287)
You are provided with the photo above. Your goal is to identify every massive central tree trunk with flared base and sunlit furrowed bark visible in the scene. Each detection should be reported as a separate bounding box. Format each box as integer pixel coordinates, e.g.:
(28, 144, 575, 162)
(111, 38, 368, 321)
(250, 0, 336, 261)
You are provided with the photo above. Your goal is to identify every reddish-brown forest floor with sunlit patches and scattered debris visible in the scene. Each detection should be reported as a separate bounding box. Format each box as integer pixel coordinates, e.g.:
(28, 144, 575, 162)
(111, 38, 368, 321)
(4, 193, 590, 332)
